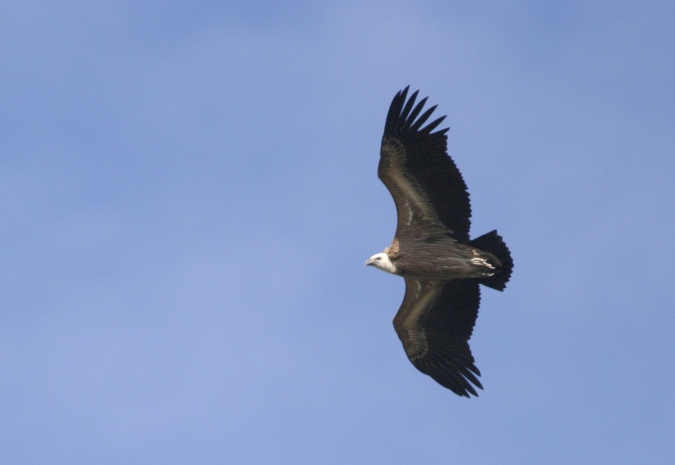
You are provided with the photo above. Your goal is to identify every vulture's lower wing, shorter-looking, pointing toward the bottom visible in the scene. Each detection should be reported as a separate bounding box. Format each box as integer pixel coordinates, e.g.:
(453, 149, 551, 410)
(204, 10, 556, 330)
(394, 278, 483, 397)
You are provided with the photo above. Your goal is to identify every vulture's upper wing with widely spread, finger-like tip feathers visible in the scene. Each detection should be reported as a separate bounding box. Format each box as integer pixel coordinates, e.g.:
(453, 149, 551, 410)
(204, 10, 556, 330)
(377, 87, 471, 243)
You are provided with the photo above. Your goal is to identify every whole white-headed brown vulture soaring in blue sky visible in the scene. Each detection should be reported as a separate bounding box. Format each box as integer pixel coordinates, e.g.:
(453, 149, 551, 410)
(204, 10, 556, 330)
(366, 87, 513, 397)
